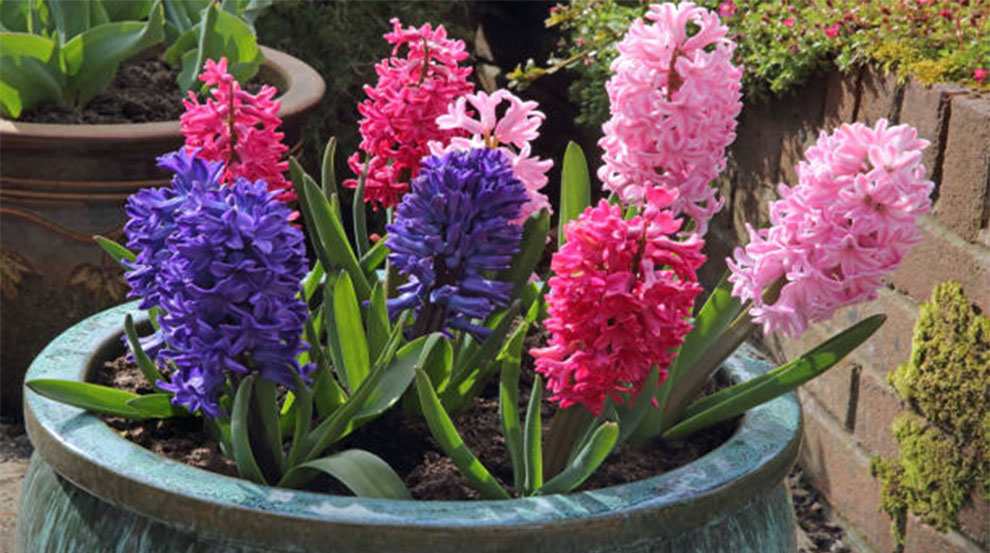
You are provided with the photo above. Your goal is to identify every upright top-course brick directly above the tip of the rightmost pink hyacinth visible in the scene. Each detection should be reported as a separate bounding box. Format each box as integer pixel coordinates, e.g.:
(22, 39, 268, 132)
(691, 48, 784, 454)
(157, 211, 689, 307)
(898, 78, 966, 179)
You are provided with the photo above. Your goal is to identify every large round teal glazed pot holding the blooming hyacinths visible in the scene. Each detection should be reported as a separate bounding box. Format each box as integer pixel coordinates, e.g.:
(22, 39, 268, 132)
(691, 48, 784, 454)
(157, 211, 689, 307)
(17, 304, 801, 553)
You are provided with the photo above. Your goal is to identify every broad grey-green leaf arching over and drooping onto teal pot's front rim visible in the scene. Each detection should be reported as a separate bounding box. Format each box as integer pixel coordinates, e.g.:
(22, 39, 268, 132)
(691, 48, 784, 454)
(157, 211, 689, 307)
(278, 449, 412, 499)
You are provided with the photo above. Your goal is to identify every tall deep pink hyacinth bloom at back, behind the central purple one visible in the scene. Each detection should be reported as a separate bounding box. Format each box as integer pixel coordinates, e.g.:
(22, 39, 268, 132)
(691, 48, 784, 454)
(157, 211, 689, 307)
(344, 19, 474, 208)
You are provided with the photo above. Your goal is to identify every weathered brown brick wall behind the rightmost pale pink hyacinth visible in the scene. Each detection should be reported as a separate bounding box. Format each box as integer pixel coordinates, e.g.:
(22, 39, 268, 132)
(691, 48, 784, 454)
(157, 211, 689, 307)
(703, 69, 990, 553)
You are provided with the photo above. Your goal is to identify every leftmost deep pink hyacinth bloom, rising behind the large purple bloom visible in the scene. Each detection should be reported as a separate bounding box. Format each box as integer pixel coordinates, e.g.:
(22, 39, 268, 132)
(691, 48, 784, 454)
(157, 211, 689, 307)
(179, 58, 296, 202)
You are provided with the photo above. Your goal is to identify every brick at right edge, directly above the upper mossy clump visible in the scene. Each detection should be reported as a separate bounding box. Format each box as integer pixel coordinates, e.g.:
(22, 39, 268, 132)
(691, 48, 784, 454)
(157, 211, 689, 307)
(890, 215, 990, 312)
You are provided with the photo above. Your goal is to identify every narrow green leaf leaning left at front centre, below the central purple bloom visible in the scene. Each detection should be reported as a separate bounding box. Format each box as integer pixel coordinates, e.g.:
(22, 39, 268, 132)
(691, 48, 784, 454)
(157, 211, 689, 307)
(416, 370, 509, 499)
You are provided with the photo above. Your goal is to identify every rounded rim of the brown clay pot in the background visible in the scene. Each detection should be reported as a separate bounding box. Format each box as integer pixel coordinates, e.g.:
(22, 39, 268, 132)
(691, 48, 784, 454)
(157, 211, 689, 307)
(0, 46, 326, 141)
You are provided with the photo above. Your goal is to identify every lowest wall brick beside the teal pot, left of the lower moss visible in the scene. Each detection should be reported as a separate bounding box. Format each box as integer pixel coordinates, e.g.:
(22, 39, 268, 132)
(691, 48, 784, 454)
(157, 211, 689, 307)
(799, 392, 894, 551)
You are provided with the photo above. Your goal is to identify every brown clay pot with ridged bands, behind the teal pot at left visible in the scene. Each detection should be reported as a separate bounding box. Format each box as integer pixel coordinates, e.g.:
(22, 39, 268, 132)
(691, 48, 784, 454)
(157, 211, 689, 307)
(0, 47, 325, 412)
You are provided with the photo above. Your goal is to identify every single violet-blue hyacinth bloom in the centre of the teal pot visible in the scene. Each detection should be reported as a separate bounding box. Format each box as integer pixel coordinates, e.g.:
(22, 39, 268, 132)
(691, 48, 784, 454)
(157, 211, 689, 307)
(387, 148, 528, 340)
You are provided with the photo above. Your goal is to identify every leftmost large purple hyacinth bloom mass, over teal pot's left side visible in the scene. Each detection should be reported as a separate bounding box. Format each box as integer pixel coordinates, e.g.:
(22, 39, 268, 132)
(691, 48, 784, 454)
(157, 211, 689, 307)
(128, 151, 311, 416)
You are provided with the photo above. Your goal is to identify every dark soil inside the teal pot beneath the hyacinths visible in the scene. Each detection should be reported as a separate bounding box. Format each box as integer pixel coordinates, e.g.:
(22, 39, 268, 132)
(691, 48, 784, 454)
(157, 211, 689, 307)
(93, 358, 739, 500)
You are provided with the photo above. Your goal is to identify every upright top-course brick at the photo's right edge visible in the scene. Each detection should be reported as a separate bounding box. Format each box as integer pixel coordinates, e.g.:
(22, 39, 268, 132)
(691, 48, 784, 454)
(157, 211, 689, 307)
(935, 92, 990, 242)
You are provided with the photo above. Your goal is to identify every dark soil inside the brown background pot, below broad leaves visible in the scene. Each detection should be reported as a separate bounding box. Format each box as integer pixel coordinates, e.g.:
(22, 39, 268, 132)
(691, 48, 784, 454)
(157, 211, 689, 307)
(18, 57, 185, 125)
